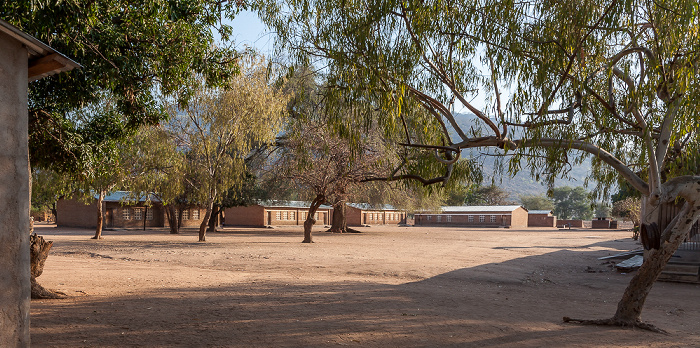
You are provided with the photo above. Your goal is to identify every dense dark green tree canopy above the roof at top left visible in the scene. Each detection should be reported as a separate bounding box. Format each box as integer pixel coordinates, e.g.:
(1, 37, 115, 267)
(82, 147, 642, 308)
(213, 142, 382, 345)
(0, 0, 238, 172)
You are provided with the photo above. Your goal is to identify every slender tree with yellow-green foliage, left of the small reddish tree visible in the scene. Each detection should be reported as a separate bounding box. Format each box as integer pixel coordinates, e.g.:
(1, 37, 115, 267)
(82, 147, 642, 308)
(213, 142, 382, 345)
(166, 58, 286, 242)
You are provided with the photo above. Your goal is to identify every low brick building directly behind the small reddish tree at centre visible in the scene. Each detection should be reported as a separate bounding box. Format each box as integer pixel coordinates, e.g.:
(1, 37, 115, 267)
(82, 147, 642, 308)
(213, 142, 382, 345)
(224, 201, 333, 227)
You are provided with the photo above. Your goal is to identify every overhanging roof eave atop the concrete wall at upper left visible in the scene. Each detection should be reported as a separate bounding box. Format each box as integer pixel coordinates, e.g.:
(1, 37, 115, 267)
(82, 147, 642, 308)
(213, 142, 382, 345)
(0, 19, 81, 82)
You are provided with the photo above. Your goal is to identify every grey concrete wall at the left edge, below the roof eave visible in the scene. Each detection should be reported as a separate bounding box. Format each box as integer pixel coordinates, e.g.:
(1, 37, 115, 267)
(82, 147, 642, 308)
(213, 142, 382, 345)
(0, 32, 31, 347)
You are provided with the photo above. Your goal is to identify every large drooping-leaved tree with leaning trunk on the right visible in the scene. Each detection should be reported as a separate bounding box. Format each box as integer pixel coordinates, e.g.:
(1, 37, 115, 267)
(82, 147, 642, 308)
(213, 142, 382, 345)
(261, 0, 700, 328)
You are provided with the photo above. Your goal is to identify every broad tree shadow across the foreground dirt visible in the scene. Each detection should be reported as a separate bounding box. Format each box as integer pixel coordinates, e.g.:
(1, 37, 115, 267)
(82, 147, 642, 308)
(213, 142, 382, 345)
(31, 241, 700, 347)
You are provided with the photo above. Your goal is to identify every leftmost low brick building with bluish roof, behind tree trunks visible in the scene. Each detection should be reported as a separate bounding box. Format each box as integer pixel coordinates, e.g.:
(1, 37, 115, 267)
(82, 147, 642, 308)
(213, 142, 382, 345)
(56, 191, 206, 228)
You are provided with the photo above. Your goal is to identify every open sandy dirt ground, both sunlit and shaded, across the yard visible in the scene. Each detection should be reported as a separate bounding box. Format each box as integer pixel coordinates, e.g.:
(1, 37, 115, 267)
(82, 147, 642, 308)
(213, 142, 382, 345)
(31, 225, 700, 347)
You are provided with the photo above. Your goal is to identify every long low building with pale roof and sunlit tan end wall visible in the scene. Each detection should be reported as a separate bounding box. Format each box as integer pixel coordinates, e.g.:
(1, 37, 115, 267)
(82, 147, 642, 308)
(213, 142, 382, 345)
(415, 205, 528, 228)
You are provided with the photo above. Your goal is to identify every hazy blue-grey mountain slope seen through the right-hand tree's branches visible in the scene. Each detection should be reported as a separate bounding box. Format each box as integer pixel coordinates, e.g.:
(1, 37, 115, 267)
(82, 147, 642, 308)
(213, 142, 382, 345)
(449, 113, 591, 201)
